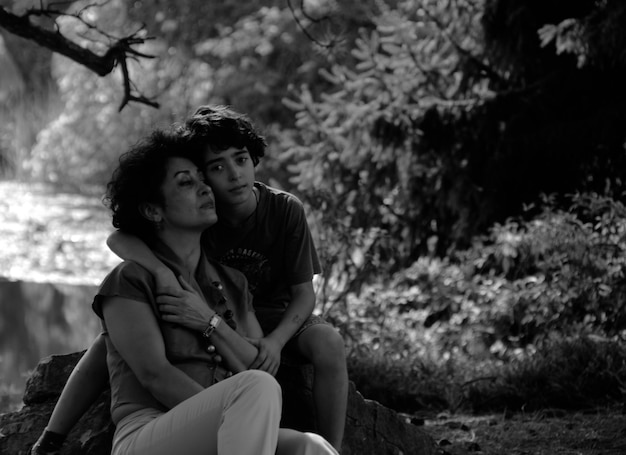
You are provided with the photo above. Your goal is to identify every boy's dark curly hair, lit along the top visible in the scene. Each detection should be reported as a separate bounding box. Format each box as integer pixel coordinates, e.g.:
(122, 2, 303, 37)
(178, 105, 267, 166)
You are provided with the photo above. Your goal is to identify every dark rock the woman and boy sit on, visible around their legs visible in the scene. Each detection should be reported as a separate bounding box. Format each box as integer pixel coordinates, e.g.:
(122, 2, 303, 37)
(0, 352, 437, 455)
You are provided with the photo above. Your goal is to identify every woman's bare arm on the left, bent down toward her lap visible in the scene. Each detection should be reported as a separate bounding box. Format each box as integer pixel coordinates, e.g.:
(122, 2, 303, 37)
(102, 297, 203, 408)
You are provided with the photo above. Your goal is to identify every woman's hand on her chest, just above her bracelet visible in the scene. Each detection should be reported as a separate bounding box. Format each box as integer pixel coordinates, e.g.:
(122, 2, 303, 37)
(156, 277, 215, 332)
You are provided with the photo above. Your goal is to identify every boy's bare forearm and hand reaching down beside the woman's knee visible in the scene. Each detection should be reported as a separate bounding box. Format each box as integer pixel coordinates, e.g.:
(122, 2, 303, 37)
(250, 281, 315, 374)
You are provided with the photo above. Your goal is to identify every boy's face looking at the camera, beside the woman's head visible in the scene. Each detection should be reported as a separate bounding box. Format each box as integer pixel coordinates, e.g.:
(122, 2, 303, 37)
(203, 147, 256, 208)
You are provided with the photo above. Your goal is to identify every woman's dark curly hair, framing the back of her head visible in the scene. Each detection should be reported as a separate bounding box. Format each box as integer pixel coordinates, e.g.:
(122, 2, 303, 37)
(103, 130, 198, 241)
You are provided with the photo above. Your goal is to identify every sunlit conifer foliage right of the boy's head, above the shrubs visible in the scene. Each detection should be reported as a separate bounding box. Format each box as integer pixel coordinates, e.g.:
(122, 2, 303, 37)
(281, 1, 486, 280)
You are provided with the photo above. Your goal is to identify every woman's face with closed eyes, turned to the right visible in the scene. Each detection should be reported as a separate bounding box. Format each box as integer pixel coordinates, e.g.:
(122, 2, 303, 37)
(156, 157, 217, 231)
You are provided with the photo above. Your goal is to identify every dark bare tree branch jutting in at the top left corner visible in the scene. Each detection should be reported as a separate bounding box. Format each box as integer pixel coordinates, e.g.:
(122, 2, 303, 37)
(0, 7, 159, 110)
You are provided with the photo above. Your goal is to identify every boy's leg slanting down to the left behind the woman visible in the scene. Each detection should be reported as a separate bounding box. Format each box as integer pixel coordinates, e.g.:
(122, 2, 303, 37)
(31, 334, 109, 454)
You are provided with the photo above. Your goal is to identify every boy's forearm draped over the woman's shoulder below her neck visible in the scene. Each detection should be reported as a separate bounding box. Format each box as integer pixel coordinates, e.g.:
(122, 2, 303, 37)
(107, 231, 180, 294)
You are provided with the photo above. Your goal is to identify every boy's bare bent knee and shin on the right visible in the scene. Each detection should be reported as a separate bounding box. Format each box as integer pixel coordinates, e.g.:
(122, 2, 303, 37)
(292, 324, 348, 451)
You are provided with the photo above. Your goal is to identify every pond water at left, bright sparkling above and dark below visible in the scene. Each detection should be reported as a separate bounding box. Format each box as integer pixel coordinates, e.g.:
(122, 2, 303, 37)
(0, 181, 119, 412)
